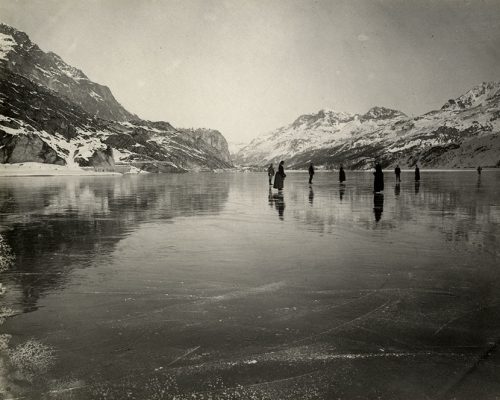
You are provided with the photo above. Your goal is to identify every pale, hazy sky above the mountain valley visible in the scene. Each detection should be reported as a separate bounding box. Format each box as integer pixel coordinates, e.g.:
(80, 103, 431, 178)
(0, 0, 500, 142)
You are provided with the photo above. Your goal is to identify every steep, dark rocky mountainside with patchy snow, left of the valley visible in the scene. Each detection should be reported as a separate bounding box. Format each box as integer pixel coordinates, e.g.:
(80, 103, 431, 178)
(0, 24, 232, 171)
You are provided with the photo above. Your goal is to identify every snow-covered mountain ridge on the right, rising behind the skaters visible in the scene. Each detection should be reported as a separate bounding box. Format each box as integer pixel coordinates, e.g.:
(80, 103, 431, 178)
(233, 82, 500, 169)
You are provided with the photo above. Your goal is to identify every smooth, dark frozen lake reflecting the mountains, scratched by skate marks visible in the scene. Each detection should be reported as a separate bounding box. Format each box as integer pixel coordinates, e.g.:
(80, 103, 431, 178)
(0, 171, 500, 400)
